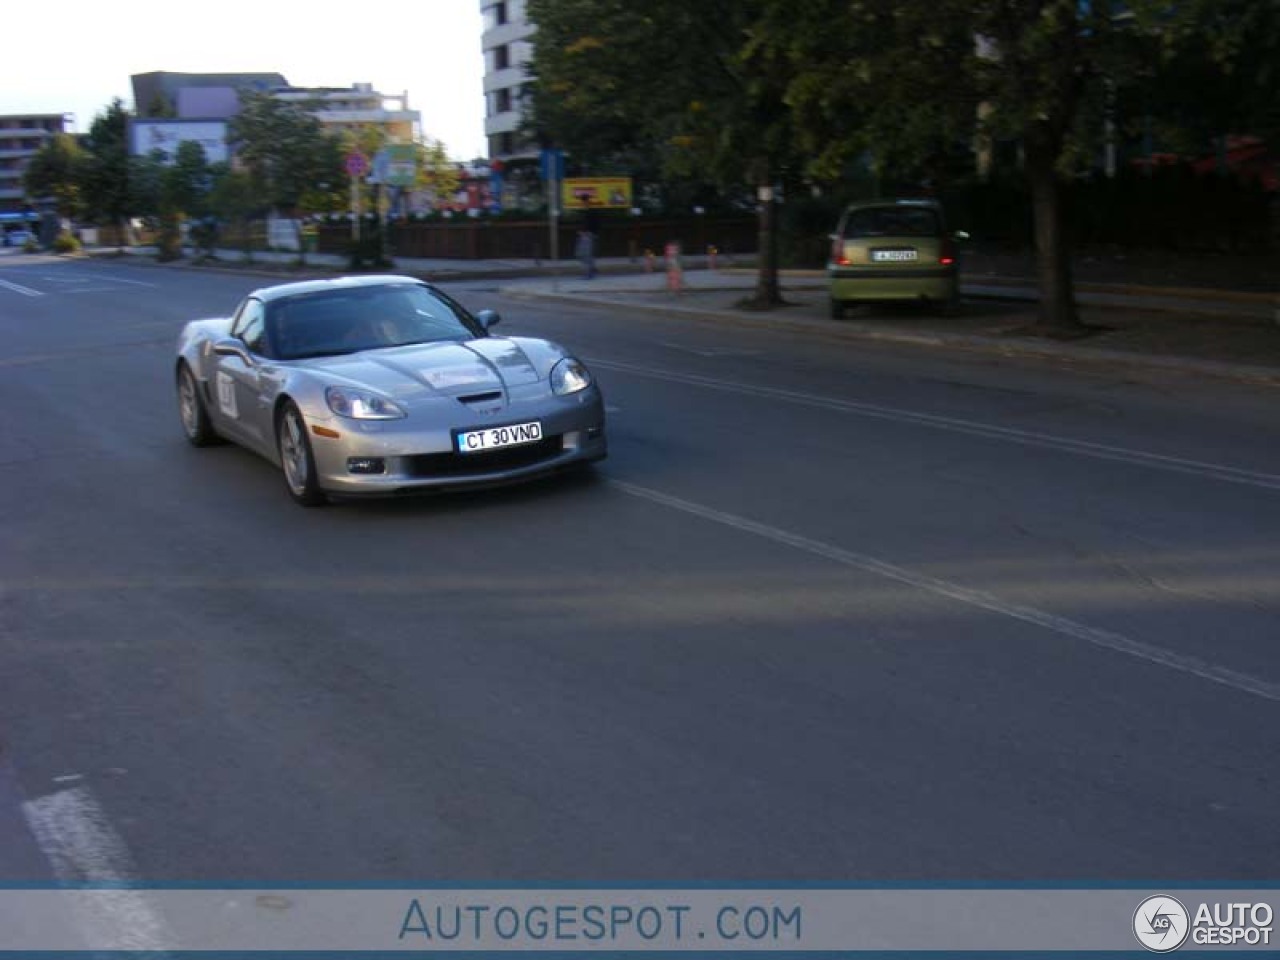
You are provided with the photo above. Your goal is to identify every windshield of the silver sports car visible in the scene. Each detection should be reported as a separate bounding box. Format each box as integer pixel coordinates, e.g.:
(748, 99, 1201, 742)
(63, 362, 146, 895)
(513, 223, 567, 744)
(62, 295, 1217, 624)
(266, 283, 484, 360)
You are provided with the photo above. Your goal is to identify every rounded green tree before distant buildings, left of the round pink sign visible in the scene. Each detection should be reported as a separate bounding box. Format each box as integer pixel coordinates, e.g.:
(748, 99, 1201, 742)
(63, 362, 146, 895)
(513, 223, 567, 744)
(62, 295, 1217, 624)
(227, 91, 346, 211)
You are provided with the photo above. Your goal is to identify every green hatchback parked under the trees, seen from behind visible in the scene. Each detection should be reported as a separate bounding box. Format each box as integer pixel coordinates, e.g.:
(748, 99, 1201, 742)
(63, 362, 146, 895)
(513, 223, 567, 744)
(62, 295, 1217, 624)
(827, 200, 968, 319)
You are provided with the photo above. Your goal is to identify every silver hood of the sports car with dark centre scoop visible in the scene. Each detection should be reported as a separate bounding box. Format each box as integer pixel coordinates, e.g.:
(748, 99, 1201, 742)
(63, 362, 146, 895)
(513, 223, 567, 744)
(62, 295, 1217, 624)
(301, 337, 564, 401)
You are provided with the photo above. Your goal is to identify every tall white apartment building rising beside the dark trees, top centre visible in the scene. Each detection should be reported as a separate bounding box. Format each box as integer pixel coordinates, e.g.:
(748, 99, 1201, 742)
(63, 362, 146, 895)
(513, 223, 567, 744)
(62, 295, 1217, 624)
(480, 0, 538, 160)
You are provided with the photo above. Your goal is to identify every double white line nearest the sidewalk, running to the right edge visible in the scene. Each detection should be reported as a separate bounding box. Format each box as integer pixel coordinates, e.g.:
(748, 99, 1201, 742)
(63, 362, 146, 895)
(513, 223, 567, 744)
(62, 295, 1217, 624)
(586, 358, 1280, 490)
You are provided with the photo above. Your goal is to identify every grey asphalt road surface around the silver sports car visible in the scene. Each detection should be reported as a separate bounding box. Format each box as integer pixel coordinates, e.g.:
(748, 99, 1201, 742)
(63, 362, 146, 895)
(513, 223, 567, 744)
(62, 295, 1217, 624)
(0, 257, 1280, 884)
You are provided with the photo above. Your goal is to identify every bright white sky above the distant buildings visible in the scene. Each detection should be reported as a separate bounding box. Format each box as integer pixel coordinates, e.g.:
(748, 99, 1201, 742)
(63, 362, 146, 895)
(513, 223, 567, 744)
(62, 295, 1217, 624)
(0, 0, 488, 160)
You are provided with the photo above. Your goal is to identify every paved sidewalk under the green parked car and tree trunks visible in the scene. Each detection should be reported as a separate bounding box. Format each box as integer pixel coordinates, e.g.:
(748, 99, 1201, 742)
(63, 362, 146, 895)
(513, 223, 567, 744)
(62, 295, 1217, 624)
(499, 270, 1280, 385)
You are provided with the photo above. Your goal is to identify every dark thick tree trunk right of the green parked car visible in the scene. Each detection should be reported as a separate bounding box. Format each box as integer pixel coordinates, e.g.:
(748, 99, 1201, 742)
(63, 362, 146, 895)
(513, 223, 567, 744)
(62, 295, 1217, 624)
(1027, 143, 1083, 337)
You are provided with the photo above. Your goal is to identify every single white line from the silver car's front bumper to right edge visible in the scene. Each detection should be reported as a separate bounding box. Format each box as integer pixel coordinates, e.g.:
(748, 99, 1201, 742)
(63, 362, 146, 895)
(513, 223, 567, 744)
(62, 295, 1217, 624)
(609, 480, 1280, 701)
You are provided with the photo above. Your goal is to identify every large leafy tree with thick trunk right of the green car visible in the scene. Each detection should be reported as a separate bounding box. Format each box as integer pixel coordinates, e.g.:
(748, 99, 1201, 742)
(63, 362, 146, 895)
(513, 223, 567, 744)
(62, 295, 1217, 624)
(773, 0, 1177, 335)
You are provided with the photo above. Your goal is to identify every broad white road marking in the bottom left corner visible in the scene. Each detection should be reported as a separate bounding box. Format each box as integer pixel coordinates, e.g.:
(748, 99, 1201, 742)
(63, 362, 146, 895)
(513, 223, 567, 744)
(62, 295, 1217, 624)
(22, 787, 175, 950)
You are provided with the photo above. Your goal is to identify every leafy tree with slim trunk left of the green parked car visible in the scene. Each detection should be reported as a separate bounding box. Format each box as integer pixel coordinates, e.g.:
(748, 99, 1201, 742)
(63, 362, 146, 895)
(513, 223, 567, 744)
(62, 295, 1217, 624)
(529, 0, 797, 307)
